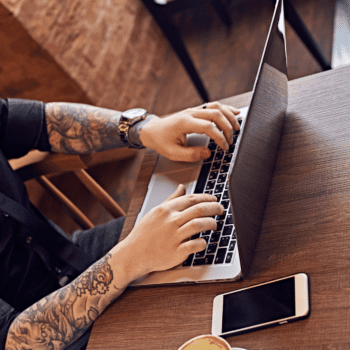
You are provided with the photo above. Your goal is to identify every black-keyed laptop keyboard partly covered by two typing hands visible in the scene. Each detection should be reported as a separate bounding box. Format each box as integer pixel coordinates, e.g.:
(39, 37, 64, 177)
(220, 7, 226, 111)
(182, 121, 242, 267)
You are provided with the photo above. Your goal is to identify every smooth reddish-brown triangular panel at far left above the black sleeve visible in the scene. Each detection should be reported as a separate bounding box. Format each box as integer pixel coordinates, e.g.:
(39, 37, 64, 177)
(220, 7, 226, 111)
(0, 4, 91, 103)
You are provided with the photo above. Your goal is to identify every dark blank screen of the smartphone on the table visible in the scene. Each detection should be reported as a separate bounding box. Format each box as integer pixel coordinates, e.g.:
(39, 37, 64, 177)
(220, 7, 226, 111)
(222, 277, 295, 333)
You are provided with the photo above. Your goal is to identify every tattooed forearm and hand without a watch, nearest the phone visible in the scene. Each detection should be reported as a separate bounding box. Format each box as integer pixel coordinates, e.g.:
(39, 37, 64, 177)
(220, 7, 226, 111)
(5, 185, 224, 350)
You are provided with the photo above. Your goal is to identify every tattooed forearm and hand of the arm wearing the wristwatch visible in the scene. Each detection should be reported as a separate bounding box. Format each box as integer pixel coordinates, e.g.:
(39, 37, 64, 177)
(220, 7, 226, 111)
(45, 102, 240, 161)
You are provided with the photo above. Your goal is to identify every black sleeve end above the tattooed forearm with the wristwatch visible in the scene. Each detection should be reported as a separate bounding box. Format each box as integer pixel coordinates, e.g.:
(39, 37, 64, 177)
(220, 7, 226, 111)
(0, 99, 50, 159)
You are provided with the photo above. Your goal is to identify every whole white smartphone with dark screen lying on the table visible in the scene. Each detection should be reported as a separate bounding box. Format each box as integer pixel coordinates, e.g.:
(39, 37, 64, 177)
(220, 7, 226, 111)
(212, 273, 310, 337)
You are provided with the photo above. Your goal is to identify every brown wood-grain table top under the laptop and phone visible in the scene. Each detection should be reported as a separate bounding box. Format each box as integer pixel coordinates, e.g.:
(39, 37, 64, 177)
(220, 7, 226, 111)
(87, 67, 350, 350)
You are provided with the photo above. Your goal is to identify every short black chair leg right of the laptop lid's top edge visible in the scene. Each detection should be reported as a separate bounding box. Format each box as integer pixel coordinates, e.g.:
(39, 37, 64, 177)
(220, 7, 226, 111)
(272, 0, 332, 70)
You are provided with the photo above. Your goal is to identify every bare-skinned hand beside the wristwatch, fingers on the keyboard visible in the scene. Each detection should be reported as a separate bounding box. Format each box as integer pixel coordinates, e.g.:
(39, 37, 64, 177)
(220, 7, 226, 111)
(139, 102, 240, 162)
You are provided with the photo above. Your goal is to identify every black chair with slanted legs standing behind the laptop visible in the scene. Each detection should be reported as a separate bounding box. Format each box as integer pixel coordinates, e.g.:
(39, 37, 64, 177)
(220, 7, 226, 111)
(142, 0, 331, 102)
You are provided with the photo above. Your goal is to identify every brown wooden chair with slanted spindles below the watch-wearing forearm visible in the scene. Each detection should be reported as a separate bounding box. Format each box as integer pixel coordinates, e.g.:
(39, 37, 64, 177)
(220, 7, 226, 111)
(9, 148, 137, 229)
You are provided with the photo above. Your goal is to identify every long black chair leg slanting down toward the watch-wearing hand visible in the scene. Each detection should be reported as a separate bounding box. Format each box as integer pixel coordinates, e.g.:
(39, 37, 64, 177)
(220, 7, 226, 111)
(142, 0, 209, 102)
